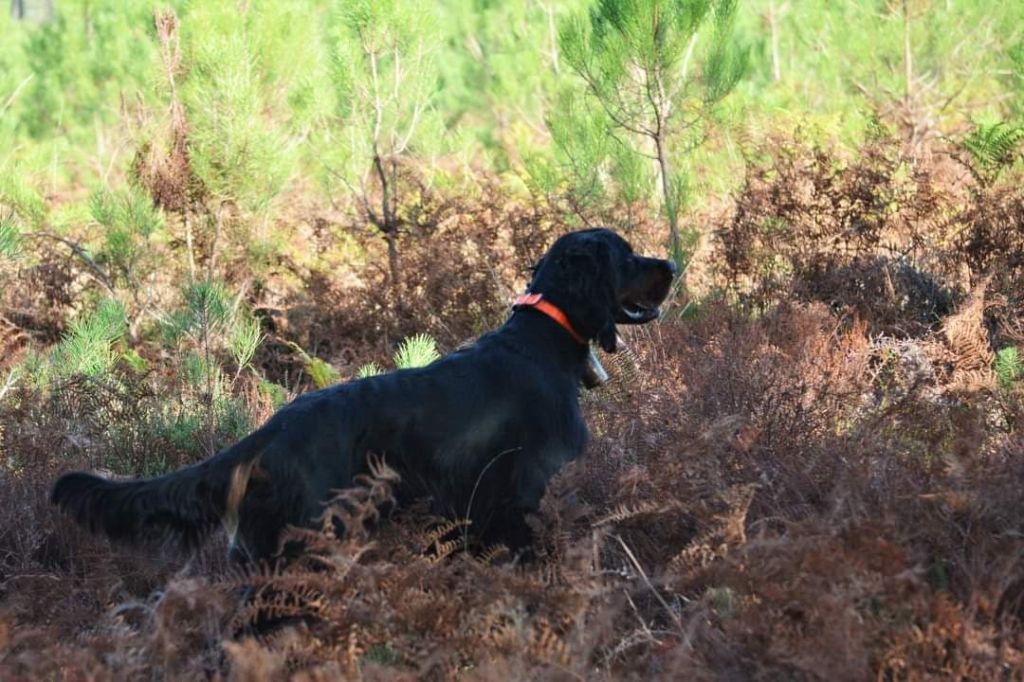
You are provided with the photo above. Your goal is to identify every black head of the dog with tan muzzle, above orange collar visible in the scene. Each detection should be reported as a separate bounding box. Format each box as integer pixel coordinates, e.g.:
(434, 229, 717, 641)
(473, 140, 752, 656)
(529, 228, 676, 352)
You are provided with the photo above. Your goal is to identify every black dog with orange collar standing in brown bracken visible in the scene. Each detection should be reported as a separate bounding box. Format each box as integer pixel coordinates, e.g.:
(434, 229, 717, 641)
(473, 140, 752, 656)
(52, 229, 675, 559)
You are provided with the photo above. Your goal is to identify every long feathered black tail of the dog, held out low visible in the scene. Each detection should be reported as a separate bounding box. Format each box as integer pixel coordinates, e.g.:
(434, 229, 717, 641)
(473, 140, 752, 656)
(50, 426, 275, 549)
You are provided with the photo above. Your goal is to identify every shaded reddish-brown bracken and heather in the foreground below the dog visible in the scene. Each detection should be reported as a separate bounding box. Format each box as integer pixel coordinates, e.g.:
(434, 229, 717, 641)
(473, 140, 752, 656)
(2, 305, 1024, 680)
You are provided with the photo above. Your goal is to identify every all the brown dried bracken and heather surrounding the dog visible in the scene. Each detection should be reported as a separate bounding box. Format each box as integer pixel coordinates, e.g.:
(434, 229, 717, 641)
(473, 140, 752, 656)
(0, 135, 1024, 680)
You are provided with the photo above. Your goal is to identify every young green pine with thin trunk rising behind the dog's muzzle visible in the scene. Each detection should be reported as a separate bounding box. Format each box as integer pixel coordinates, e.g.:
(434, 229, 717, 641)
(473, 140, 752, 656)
(559, 0, 746, 261)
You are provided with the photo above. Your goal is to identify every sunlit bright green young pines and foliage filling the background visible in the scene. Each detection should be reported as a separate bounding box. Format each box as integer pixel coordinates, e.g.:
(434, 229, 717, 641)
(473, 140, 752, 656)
(0, 0, 1024, 466)
